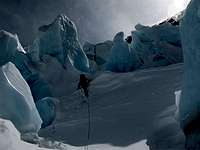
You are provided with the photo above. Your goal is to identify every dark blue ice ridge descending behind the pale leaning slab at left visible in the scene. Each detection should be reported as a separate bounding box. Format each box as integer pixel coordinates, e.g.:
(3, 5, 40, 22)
(0, 31, 52, 101)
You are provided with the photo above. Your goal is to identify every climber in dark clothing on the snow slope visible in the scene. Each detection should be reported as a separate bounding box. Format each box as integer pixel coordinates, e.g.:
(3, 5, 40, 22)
(78, 74, 91, 98)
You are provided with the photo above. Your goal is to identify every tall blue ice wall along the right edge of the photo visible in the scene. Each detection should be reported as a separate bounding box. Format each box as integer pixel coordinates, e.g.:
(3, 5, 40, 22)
(179, 0, 200, 150)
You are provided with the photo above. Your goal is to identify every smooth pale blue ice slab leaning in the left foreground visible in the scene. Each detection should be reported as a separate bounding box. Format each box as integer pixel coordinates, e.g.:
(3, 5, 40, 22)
(0, 63, 42, 134)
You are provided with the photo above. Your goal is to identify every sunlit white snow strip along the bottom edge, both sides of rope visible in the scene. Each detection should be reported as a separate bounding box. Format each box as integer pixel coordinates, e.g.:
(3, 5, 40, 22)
(0, 118, 148, 150)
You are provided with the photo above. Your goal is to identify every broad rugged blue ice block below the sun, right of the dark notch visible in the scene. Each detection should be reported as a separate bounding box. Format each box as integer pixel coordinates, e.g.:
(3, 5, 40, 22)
(131, 22, 183, 67)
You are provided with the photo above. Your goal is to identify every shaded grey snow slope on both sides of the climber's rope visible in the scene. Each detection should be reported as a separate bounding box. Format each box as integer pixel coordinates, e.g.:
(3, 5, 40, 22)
(40, 64, 183, 149)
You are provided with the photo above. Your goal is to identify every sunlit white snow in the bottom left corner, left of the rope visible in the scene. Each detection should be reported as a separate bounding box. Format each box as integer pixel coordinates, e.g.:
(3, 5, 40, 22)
(0, 118, 81, 150)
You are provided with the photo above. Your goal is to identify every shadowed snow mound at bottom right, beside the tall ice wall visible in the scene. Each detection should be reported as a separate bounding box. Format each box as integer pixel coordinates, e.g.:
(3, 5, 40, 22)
(147, 105, 185, 150)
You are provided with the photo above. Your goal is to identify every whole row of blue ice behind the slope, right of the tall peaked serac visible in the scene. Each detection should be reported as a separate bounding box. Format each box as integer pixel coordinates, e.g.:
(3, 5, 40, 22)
(83, 12, 184, 72)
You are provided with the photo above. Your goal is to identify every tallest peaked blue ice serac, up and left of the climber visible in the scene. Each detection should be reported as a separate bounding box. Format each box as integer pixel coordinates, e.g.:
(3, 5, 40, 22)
(29, 15, 89, 72)
